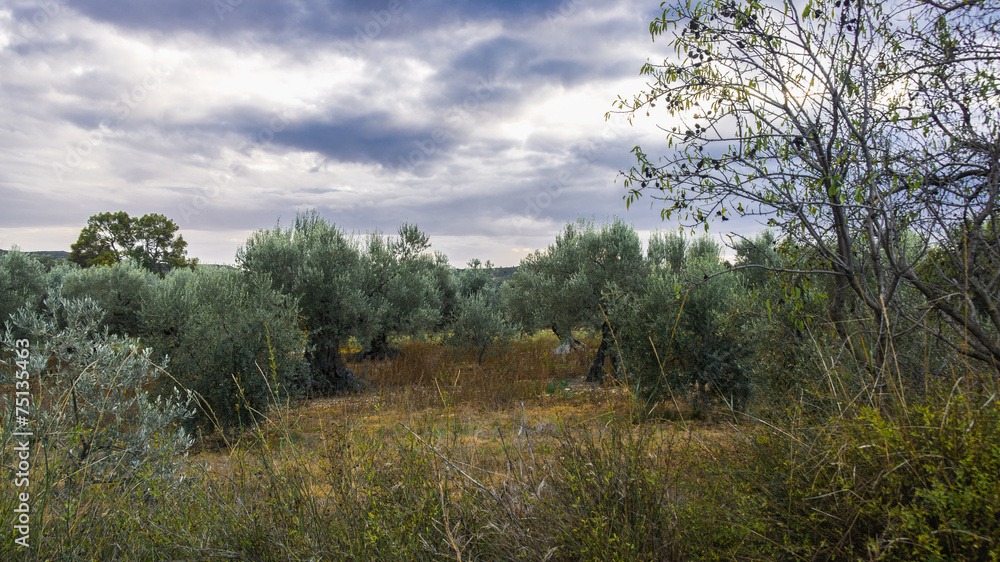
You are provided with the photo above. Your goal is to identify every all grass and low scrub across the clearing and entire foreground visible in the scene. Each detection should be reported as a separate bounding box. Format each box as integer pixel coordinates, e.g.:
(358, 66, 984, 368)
(0, 332, 1000, 560)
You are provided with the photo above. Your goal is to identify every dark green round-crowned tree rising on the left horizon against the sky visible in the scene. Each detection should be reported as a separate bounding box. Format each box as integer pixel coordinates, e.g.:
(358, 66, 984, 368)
(66, 211, 198, 276)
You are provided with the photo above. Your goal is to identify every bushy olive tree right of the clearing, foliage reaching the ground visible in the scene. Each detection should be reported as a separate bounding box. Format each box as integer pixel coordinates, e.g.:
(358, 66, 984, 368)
(612, 233, 753, 410)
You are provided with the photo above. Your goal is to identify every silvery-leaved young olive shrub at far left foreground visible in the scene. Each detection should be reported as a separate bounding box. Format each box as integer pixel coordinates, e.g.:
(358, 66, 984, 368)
(3, 294, 192, 490)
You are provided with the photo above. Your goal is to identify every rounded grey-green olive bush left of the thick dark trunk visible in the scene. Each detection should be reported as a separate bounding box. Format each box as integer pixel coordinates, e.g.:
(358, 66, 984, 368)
(142, 267, 308, 429)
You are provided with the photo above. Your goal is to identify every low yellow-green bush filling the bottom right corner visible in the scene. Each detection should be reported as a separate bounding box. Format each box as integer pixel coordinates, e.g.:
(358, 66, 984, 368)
(707, 378, 1000, 560)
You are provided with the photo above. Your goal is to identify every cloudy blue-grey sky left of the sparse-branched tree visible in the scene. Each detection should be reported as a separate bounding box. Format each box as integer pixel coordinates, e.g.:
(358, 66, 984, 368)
(0, 0, 720, 266)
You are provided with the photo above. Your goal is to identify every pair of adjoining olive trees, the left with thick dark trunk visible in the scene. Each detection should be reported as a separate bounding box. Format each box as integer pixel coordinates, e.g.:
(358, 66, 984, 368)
(236, 211, 450, 391)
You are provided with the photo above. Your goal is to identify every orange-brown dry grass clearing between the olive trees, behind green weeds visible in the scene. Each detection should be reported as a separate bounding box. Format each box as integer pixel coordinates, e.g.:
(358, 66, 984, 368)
(192, 335, 733, 482)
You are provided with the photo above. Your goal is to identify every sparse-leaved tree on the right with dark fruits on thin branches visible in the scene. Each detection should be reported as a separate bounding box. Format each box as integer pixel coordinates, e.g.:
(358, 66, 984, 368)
(609, 0, 1000, 375)
